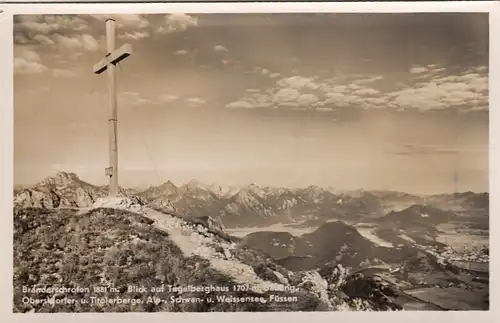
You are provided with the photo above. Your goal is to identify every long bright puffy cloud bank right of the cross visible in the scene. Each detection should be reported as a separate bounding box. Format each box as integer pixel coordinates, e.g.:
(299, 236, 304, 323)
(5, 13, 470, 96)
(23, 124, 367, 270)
(227, 65, 488, 111)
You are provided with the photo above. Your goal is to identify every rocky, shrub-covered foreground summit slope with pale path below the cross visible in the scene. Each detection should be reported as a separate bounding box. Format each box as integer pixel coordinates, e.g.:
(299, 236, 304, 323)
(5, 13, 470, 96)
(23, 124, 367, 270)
(14, 198, 399, 312)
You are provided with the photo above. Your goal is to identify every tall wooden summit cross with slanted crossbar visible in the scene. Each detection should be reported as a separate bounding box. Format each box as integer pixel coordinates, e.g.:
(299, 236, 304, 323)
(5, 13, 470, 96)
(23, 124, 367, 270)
(94, 19, 132, 196)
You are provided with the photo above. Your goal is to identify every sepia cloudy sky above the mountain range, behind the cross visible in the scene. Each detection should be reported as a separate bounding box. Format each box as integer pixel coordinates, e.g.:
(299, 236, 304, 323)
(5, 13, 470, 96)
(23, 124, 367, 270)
(14, 13, 488, 193)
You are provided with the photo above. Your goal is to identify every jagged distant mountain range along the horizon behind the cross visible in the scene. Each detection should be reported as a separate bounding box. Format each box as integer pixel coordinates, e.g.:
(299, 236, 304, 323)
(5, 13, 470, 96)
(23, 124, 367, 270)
(14, 172, 489, 228)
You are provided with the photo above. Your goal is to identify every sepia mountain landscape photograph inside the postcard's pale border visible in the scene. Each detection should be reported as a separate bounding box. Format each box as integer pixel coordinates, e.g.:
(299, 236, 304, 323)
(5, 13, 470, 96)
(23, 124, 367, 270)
(12, 5, 490, 313)
